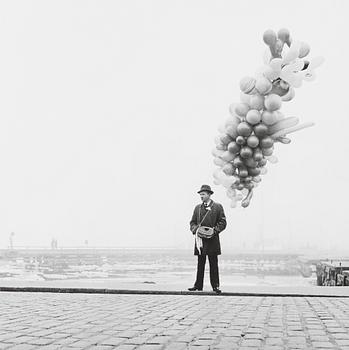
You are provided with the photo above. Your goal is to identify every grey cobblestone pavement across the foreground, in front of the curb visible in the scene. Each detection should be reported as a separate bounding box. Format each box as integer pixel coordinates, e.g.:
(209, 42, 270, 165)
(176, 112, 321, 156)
(0, 292, 349, 350)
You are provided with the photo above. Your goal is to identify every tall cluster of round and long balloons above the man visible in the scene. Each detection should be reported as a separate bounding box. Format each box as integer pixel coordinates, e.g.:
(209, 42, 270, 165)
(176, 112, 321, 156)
(212, 29, 323, 208)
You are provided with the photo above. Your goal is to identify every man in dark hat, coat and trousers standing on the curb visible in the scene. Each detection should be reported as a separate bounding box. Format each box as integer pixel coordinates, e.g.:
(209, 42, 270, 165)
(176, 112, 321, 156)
(188, 185, 227, 294)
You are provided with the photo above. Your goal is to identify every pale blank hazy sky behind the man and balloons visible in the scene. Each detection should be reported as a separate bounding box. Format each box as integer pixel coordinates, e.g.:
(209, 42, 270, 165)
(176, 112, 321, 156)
(0, 0, 349, 253)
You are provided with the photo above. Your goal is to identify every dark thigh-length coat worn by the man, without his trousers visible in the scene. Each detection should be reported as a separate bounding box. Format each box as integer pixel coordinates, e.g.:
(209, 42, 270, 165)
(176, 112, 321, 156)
(190, 200, 227, 255)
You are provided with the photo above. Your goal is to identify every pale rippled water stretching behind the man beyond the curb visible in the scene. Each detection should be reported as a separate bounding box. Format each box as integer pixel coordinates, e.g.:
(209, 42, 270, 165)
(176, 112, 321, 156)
(0, 249, 316, 290)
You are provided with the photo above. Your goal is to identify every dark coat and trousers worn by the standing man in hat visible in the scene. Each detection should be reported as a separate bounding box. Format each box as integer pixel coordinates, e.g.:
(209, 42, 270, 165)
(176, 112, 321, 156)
(190, 200, 227, 289)
